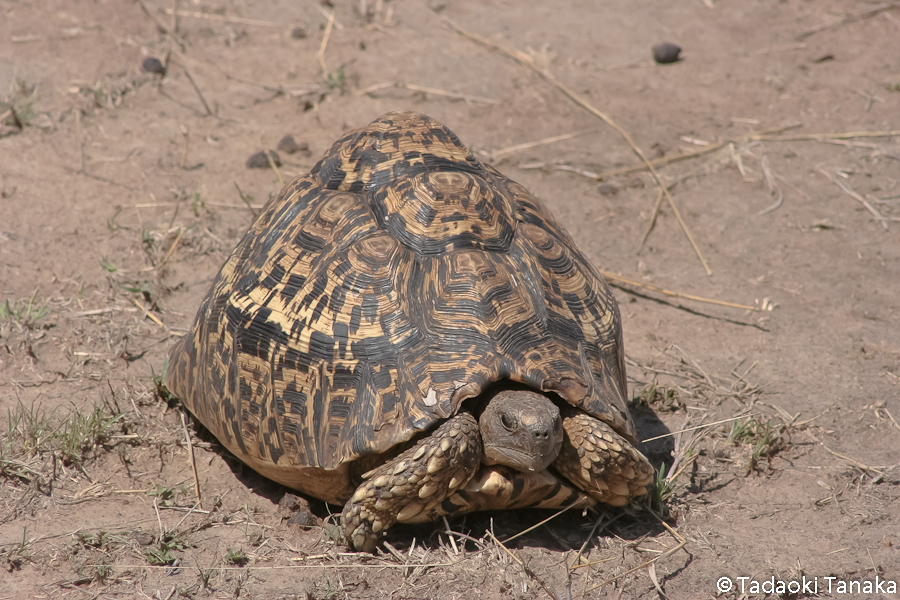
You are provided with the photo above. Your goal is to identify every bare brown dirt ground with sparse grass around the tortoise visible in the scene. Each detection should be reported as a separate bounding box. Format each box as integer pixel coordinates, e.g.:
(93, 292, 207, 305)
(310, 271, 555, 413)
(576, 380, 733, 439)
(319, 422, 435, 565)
(0, 0, 900, 600)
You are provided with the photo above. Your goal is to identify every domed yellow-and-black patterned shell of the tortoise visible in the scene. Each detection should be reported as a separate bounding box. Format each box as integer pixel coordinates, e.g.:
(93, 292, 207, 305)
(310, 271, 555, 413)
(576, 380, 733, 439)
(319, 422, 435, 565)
(167, 113, 634, 501)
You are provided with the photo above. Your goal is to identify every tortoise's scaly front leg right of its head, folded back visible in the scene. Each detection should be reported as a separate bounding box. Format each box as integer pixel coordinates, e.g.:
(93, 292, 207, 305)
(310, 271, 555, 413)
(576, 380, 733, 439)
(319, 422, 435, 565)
(553, 407, 653, 506)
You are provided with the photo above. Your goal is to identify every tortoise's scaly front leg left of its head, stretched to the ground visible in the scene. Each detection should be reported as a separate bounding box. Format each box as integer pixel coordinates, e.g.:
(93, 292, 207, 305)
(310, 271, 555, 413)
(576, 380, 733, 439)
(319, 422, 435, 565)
(341, 413, 484, 552)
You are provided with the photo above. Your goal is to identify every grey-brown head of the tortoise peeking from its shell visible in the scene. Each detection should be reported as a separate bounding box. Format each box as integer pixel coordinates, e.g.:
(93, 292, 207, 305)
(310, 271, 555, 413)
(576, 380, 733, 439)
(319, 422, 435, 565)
(479, 390, 563, 471)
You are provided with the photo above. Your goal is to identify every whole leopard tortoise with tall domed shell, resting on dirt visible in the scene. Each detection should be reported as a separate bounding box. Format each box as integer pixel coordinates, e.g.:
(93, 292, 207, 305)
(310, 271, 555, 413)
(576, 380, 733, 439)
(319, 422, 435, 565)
(166, 112, 653, 551)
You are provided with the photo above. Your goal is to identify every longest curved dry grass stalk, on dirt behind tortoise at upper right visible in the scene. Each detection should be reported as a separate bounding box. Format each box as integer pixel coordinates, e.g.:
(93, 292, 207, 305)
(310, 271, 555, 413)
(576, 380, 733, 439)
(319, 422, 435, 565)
(444, 19, 712, 275)
